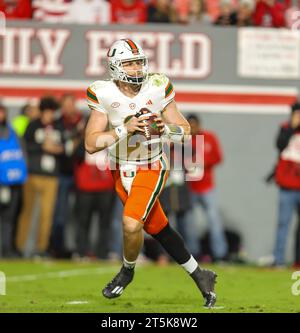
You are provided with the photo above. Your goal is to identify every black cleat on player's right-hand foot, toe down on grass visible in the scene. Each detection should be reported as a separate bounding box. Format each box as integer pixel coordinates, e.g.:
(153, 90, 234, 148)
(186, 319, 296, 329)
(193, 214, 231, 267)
(192, 268, 217, 308)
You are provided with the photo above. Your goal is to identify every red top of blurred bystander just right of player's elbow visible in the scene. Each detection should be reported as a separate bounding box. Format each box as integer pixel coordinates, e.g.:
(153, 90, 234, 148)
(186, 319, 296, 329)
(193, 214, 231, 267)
(189, 130, 223, 193)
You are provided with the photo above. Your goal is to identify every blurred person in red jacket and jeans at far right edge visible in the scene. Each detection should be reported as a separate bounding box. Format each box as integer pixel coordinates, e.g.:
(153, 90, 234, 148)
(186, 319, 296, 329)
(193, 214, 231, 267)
(274, 102, 300, 266)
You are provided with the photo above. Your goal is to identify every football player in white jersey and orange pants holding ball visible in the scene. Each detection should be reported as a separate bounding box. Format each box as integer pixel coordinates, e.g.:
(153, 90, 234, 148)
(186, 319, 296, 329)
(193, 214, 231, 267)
(85, 39, 216, 307)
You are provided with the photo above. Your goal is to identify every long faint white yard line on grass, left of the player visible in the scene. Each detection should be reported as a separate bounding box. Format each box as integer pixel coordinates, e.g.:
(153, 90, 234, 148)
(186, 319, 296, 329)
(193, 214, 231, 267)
(6, 266, 119, 282)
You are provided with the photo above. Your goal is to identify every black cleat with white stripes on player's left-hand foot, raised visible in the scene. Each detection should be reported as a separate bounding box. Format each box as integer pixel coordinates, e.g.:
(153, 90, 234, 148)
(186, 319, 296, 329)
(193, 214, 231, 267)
(102, 266, 134, 298)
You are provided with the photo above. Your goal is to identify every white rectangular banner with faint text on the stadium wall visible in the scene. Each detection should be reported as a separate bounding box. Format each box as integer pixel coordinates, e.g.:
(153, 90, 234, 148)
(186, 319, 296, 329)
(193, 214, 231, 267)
(238, 28, 300, 79)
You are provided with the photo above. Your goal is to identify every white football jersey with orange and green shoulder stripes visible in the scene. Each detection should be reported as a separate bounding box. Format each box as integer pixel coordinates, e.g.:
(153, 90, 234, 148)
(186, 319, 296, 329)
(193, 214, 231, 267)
(87, 74, 175, 164)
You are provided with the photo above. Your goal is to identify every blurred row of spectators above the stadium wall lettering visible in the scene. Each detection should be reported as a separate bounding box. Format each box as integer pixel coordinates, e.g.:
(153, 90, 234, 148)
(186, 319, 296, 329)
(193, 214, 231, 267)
(0, 0, 300, 29)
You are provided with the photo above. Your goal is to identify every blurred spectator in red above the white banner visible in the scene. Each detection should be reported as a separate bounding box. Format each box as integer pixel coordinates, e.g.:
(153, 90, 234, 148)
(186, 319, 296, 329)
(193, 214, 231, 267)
(253, 0, 286, 28)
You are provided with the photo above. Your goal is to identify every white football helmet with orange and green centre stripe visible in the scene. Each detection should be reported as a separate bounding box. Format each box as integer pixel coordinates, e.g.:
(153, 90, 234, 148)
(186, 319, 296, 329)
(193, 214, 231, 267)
(107, 39, 148, 84)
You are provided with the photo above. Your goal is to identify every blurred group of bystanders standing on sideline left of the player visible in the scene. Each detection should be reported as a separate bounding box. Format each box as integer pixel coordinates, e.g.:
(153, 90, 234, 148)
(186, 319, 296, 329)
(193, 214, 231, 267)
(0, 93, 118, 258)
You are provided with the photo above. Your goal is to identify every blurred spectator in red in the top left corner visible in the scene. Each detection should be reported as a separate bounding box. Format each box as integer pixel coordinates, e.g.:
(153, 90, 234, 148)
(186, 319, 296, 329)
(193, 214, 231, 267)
(0, 0, 32, 20)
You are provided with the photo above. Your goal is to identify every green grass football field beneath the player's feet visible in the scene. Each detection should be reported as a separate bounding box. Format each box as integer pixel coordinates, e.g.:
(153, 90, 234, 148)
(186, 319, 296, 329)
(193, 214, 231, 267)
(0, 261, 300, 313)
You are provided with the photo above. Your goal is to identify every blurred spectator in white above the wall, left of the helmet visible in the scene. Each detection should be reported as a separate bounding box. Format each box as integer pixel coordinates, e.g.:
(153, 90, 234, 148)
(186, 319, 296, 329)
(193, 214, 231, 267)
(67, 0, 111, 25)
